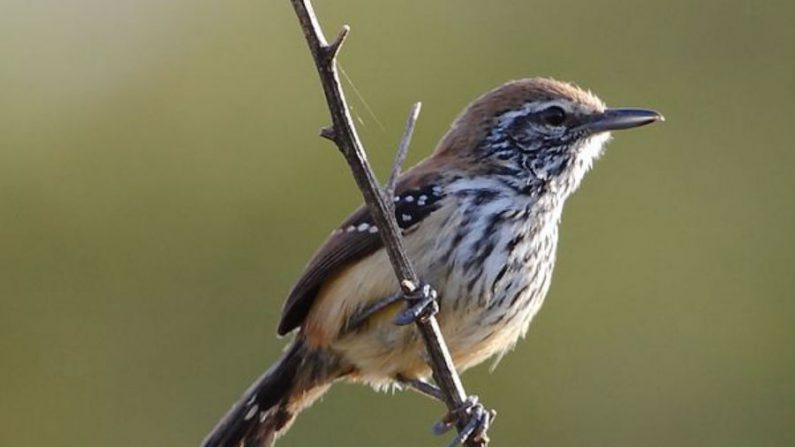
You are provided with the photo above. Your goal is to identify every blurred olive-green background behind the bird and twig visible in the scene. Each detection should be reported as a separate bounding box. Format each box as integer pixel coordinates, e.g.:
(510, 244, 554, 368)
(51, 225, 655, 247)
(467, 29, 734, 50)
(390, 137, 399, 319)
(0, 0, 795, 447)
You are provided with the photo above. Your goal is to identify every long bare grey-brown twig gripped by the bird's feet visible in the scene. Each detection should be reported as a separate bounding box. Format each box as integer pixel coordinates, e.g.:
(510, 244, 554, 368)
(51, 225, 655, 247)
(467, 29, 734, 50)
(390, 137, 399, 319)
(291, 0, 486, 447)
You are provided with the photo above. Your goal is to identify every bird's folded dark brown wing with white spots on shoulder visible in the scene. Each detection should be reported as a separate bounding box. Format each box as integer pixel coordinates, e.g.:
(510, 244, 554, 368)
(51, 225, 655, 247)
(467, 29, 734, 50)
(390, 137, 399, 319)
(277, 165, 444, 335)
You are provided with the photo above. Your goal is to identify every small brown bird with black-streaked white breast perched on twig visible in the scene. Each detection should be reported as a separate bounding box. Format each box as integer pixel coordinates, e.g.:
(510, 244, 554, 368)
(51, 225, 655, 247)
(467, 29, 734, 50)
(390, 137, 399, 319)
(203, 78, 663, 447)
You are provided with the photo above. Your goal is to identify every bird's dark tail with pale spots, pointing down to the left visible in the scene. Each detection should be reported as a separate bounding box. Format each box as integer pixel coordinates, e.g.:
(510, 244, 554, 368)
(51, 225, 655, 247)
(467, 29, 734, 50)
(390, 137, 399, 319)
(201, 338, 343, 447)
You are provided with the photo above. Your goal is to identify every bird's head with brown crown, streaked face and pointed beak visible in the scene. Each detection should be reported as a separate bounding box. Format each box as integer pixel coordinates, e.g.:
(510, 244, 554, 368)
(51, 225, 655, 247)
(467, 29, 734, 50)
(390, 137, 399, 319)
(437, 78, 663, 196)
